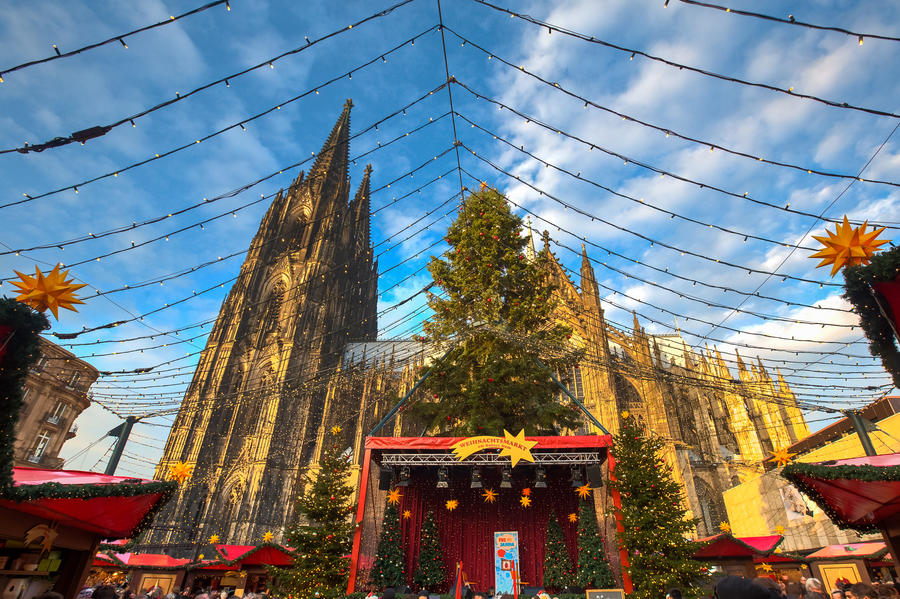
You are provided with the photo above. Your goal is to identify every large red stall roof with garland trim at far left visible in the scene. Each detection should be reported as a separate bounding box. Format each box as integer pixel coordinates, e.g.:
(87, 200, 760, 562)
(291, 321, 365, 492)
(0, 468, 177, 539)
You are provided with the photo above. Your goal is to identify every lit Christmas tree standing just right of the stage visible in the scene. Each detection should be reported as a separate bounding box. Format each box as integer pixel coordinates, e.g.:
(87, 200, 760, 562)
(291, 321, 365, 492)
(612, 412, 704, 599)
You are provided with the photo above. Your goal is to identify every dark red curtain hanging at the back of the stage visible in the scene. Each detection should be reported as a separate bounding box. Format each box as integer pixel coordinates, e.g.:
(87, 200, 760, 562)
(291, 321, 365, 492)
(399, 466, 578, 591)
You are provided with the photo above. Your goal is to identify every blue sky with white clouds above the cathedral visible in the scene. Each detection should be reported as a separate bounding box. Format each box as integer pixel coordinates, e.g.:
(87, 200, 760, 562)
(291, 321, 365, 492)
(0, 0, 900, 475)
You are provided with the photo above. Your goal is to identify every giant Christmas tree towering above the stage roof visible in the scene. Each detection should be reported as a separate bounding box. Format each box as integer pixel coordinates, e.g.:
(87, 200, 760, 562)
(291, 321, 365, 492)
(413, 187, 579, 436)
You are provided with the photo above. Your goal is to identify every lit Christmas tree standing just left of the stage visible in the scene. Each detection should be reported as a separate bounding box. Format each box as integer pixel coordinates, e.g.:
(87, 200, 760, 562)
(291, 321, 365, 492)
(270, 427, 353, 599)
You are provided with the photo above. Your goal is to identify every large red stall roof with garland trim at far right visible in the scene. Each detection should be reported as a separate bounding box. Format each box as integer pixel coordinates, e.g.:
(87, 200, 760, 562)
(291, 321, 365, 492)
(781, 453, 900, 532)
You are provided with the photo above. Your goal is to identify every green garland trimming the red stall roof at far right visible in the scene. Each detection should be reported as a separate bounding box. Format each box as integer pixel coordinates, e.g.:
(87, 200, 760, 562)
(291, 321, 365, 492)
(781, 462, 900, 532)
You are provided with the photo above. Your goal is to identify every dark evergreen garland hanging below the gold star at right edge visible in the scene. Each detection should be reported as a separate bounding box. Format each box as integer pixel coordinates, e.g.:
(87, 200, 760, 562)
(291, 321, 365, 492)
(844, 247, 900, 387)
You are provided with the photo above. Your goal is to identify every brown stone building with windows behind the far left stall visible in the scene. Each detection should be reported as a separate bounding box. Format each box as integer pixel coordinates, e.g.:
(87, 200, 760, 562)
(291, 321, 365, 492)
(13, 337, 100, 468)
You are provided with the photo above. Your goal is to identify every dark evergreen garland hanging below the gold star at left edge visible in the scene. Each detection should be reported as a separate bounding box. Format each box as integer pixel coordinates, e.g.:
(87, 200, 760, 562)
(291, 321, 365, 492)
(0, 297, 50, 495)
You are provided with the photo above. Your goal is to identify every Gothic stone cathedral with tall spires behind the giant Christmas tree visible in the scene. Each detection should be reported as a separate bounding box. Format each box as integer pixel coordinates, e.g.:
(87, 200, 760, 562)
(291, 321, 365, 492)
(139, 100, 809, 556)
